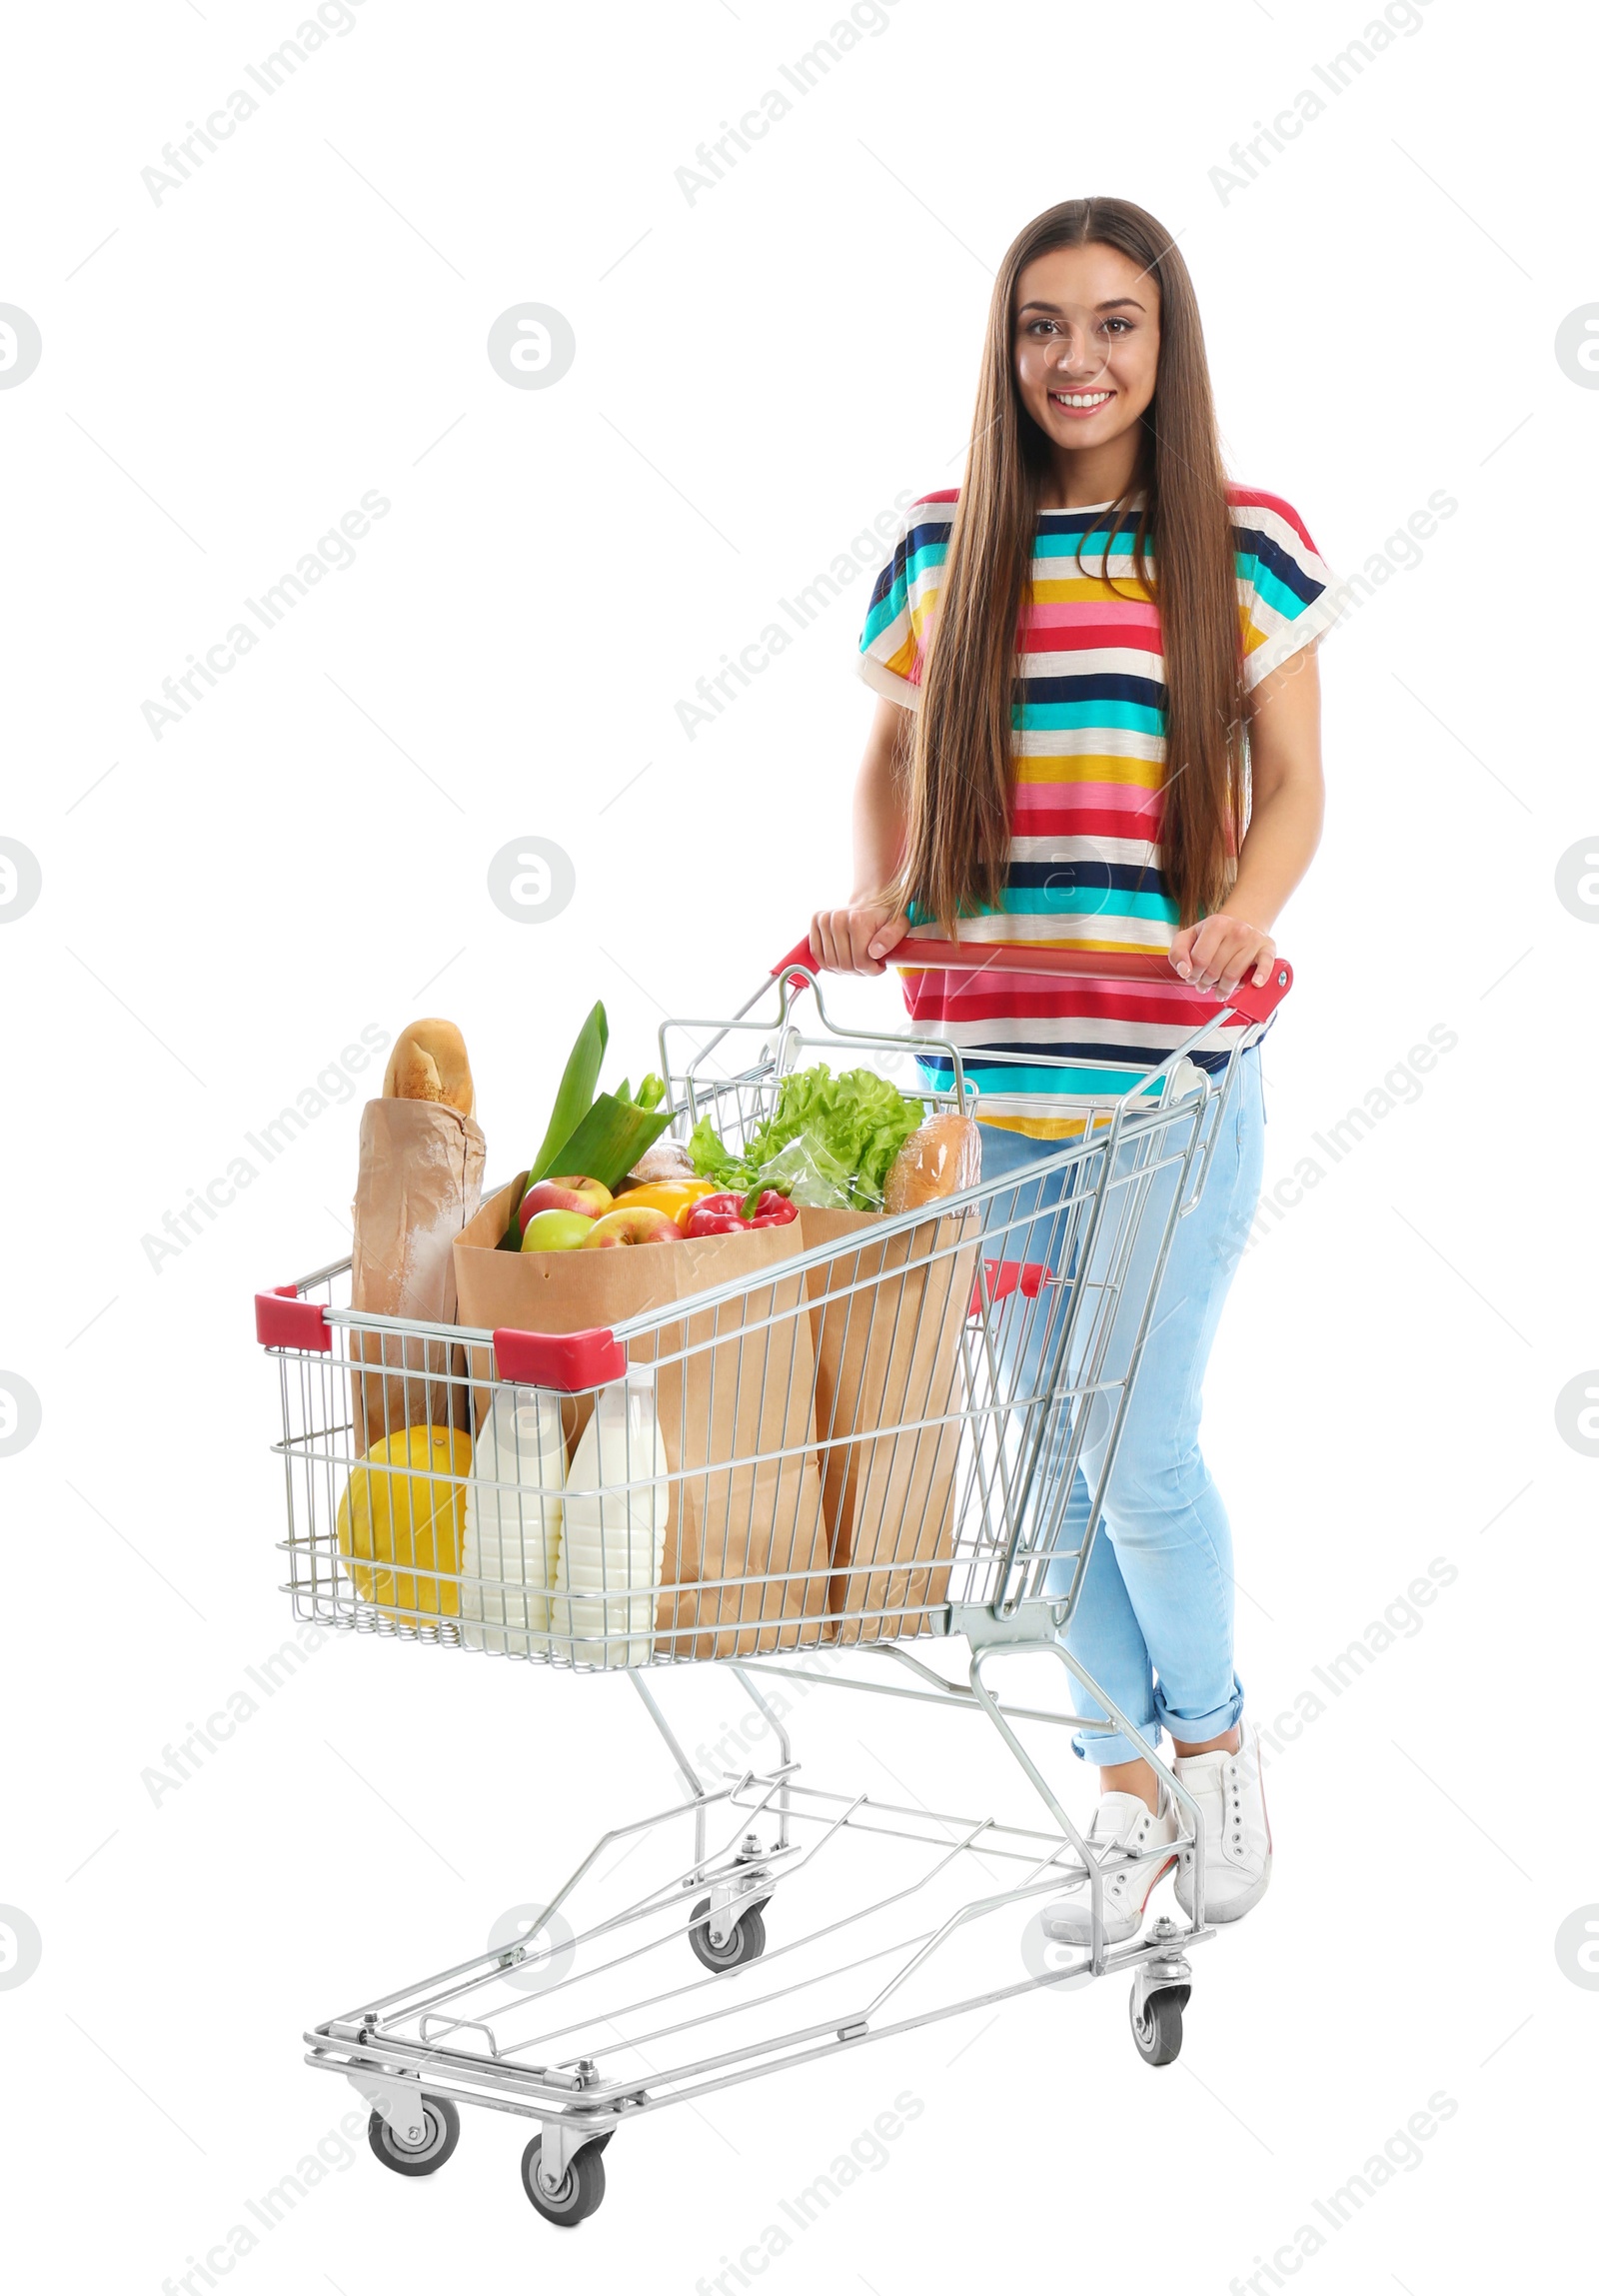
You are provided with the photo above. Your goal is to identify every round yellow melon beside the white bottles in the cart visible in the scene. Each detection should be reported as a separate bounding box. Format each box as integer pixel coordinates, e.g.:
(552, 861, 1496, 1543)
(340, 1428, 473, 1623)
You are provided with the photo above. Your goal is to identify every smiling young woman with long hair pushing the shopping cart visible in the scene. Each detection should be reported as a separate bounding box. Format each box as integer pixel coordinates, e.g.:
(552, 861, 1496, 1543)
(809, 200, 1340, 1942)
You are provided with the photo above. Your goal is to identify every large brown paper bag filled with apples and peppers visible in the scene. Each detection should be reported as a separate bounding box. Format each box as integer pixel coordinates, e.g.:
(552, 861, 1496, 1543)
(455, 1184, 830, 1657)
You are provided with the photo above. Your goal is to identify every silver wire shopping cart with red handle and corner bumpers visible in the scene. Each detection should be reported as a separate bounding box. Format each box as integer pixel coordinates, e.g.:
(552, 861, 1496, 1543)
(257, 942, 1291, 2225)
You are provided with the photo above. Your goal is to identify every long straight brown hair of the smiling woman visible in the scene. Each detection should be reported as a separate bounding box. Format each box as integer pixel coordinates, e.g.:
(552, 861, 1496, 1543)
(899, 200, 1245, 937)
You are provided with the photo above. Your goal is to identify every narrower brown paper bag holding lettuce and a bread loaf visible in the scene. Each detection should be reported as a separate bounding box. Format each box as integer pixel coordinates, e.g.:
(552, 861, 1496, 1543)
(800, 1207, 979, 1641)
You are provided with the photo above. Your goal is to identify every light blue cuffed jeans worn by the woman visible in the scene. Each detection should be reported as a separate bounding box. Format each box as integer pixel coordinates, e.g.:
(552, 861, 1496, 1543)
(981, 1050, 1266, 1765)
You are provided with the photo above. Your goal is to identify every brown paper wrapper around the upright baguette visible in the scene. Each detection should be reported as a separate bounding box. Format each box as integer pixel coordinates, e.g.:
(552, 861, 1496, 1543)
(351, 1100, 484, 1458)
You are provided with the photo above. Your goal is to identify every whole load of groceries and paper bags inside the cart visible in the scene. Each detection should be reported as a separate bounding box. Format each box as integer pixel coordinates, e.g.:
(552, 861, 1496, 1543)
(286, 1004, 981, 1667)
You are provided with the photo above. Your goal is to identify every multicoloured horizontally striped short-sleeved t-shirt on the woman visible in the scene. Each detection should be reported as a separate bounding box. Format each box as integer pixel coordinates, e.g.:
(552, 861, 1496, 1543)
(860, 487, 1342, 1135)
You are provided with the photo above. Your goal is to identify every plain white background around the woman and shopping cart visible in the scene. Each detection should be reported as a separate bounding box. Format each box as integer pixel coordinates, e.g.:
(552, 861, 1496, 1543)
(0, 0, 1599, 2296)
